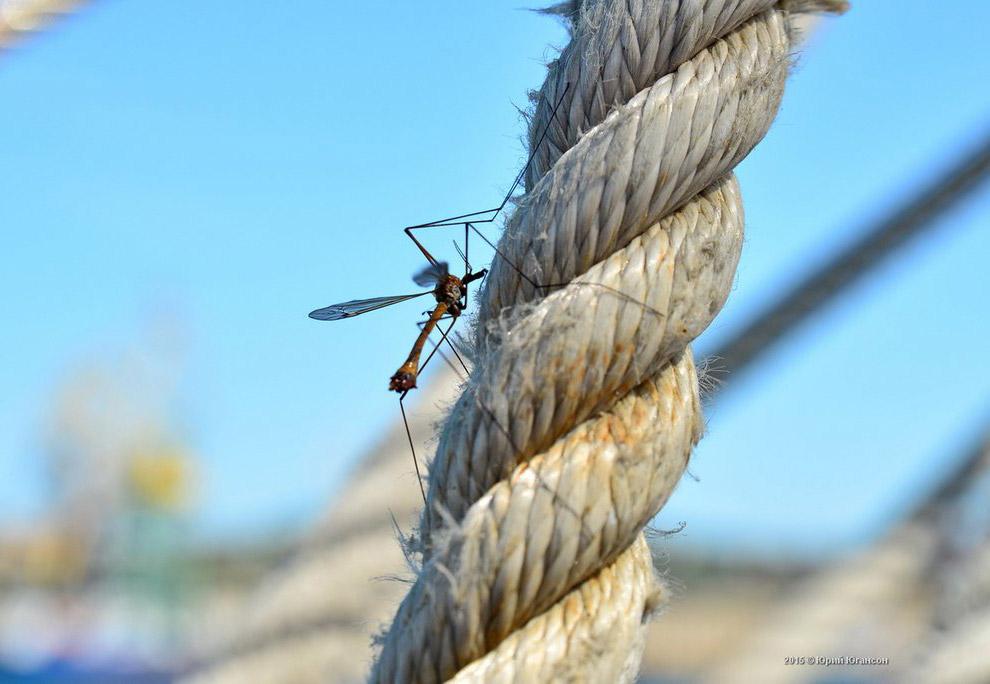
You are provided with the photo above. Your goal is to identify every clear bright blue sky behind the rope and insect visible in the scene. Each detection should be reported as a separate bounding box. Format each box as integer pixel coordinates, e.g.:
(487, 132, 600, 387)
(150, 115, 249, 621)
(0, 0, 990, 552)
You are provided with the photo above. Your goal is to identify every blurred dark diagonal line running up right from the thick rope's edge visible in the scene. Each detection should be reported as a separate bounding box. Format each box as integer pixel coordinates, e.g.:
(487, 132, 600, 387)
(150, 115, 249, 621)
(709, 130, 990, 382)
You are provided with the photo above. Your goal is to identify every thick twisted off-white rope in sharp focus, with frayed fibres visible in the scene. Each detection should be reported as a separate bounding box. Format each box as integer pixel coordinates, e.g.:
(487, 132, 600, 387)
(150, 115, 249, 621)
(372, 0, 842, 682)
